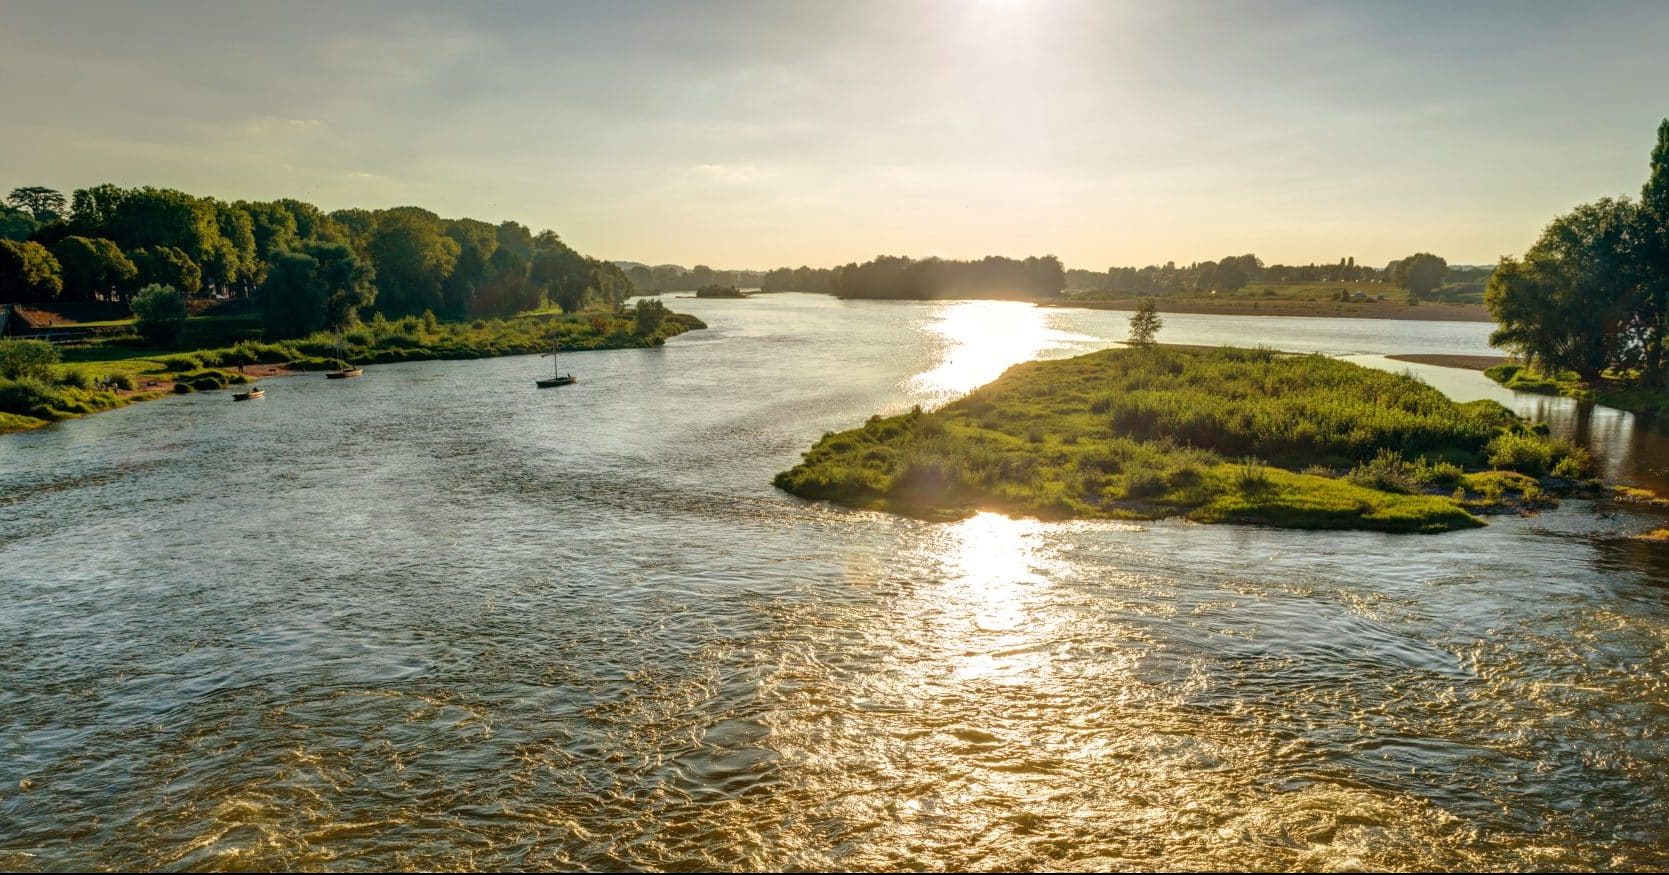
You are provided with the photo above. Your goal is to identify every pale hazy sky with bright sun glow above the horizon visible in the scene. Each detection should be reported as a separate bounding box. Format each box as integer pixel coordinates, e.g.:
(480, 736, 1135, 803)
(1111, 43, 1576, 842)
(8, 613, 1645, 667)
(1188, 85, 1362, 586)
(0, 0, 1669, 271)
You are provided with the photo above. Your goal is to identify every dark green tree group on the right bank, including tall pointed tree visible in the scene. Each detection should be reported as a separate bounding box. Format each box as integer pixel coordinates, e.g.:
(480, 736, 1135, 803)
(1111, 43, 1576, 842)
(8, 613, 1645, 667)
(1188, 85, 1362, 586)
(1484, 119, 1669, 389)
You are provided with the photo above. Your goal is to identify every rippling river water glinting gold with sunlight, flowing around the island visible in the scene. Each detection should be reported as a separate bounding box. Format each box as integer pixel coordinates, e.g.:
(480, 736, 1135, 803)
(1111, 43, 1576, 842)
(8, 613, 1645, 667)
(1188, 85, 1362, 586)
(0, 296, 1669, 870)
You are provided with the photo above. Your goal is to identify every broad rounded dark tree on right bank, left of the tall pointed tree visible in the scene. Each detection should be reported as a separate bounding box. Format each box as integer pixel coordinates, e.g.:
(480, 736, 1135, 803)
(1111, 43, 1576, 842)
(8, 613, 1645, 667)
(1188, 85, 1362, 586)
(1484, 197, 1641, 382)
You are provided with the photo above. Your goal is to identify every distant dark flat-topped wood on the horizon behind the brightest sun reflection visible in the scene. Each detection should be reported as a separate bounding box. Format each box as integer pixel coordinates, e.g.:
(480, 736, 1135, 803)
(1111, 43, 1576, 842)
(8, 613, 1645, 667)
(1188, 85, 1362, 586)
(829, 255, 1066, 301)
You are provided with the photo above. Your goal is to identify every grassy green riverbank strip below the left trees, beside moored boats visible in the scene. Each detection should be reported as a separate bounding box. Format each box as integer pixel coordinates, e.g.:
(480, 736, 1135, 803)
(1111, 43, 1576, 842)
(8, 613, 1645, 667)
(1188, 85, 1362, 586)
(0, 309, 706, 434)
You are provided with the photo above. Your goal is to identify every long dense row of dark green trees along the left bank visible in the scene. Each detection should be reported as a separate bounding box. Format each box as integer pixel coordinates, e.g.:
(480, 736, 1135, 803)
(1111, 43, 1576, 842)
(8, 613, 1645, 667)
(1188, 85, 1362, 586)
(0, 185, 631, 334)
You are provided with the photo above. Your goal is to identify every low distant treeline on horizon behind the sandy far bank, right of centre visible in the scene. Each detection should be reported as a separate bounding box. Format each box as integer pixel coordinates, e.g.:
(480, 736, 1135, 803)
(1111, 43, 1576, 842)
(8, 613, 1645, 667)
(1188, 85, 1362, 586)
(1066, 252, 1492, 299)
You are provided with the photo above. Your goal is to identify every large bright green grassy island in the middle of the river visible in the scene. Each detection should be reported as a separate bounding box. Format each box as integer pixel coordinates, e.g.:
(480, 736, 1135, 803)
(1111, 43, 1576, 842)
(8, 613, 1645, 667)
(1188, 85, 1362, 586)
(776, 347, 1591, 533)
